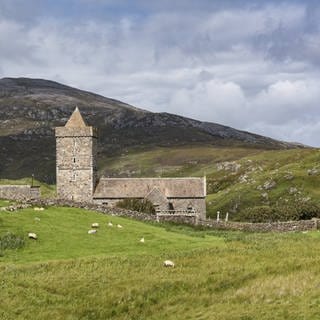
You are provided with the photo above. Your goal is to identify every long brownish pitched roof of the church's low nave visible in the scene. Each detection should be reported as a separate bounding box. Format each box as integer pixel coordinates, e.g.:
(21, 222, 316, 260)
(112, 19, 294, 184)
(93, 178, 206, 199)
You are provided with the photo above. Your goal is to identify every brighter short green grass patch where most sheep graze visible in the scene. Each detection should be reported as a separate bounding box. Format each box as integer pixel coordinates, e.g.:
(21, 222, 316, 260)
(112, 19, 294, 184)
(0, 207, 222, 263)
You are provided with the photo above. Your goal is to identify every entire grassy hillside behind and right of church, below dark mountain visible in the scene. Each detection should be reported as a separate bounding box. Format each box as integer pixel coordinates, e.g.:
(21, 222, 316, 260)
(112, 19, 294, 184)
(100, 146, 320, 218)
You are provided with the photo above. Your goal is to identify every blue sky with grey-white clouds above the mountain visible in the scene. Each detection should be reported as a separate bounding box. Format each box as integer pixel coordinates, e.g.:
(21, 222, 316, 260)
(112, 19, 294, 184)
(0, 0, 320, 147)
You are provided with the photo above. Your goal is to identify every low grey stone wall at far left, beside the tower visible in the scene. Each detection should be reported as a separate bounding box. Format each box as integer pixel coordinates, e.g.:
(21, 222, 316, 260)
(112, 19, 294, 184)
(0, 185, 40, 200)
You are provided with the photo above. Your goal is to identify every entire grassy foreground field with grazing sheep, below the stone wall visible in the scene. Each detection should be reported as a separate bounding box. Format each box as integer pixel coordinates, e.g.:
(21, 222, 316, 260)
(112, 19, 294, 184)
(0, 203, 320, 320)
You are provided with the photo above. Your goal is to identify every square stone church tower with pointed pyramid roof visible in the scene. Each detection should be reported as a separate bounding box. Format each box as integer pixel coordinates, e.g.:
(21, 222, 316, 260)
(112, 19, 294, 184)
(55, 108, 97, 202)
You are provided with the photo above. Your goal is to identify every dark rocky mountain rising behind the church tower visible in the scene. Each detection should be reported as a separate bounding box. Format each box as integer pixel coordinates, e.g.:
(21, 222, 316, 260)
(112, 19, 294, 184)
(0, 78, 294, 183)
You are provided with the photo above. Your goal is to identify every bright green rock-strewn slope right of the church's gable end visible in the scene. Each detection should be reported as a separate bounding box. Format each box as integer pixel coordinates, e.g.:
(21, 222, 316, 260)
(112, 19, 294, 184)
(207, 149, 320, 216)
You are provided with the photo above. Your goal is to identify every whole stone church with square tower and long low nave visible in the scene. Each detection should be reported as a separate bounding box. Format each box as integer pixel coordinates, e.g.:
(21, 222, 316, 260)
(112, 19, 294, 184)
(55, 108, 206, 219)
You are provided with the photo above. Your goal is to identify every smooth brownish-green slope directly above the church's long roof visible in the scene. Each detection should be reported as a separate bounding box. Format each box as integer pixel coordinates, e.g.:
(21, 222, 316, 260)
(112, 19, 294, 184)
(99, 145, 263, 177)
